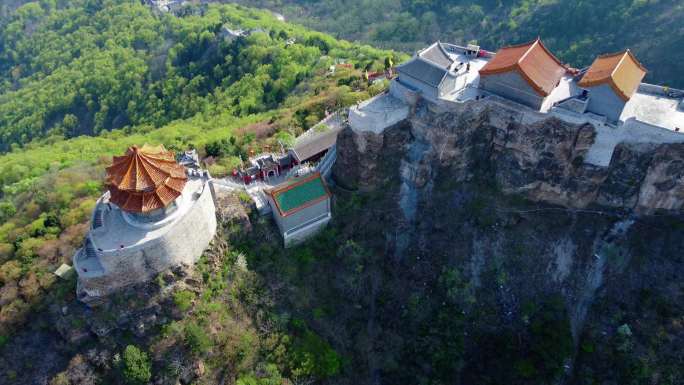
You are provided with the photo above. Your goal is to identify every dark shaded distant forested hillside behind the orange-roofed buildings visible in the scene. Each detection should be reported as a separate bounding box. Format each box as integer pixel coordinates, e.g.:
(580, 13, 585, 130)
(238, 0, 684, 87)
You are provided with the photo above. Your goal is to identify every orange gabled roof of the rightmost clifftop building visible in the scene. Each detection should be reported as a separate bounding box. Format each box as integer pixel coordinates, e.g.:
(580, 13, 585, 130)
(578, 50, 647, 101)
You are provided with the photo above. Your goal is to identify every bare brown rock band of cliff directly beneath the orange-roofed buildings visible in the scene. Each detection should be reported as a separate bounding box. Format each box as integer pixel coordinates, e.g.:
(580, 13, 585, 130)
(336, 101, 684, 214)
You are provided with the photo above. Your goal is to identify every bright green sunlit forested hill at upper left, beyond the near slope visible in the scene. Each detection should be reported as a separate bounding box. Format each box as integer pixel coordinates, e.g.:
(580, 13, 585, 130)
(0, 0, 398, 151)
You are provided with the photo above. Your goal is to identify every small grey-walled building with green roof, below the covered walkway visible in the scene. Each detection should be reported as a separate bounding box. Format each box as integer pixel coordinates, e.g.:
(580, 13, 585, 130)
(266, 172, 332, 247)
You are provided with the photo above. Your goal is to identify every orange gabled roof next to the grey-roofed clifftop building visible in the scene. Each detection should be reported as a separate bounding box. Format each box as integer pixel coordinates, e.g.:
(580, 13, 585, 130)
(480, 39, 566, 96)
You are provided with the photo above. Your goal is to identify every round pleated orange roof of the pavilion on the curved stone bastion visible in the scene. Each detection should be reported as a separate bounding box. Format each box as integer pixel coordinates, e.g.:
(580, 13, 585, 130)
(106, 145, 187, 213)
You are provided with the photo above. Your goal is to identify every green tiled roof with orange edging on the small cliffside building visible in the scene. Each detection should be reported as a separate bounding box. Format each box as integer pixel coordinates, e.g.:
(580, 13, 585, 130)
(268, 172, 330, 217)
